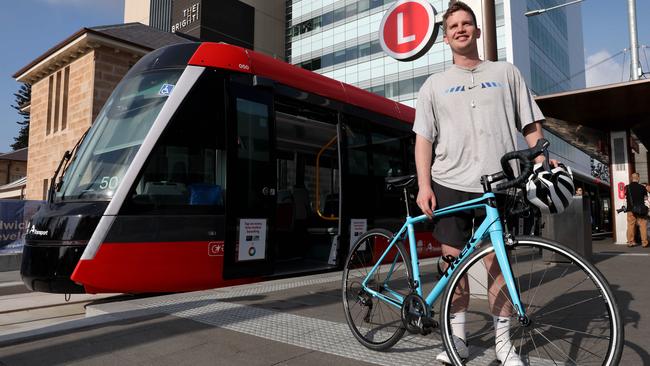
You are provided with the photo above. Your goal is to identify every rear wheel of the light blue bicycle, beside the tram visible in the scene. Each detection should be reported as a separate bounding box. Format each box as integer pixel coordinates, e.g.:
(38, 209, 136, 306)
(342, 229, 412, 351)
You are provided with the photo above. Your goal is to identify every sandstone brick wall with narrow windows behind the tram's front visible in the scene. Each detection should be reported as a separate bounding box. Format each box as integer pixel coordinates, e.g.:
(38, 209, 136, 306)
(26, 46, 142, 200)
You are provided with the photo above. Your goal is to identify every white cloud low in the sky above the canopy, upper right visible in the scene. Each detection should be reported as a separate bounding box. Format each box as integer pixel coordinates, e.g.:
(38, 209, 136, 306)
(585, 50, 630, 87)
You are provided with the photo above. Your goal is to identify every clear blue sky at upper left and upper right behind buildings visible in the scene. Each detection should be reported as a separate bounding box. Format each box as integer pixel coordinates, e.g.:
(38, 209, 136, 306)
(0, 0, 650, 152)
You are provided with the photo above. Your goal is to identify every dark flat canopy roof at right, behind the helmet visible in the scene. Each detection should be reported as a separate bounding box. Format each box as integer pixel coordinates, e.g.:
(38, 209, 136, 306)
(535, 79, 650, 162)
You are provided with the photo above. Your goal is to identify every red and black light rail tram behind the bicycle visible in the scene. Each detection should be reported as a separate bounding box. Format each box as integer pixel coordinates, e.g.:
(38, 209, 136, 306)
(21, 43, 439, 293)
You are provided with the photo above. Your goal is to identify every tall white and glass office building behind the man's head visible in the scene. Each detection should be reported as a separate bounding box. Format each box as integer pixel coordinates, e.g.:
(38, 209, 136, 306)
(285, 0, 591, 173)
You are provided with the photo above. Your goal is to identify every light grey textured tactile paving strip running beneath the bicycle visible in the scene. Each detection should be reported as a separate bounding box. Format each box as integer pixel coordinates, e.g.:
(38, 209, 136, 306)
(140, 275, 548, 366)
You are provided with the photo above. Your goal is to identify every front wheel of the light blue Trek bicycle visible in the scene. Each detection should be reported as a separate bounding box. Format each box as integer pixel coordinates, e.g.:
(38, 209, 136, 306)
(441, 237, 624, 365)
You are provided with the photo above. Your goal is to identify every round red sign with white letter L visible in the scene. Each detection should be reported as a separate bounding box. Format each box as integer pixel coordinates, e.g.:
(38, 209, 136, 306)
(379, 0, 438, 61)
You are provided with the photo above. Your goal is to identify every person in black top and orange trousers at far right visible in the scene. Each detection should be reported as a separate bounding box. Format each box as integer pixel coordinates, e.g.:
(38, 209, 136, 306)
(625, 173, 648, 248)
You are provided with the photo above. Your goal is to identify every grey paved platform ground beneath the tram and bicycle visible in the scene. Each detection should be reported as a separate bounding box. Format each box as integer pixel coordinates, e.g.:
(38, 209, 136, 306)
(0, 239, 650, 366)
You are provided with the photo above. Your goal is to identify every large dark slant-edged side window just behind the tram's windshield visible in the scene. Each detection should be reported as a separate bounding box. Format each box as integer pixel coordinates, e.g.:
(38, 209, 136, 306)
(125, 71, 226, 214)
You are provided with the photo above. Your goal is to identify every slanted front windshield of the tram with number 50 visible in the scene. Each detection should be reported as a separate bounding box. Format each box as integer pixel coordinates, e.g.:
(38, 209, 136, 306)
(56, 69, 183, 200)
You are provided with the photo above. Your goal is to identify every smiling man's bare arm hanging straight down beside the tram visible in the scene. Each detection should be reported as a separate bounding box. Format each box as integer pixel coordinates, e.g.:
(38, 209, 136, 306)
(415, 134, 436, 217)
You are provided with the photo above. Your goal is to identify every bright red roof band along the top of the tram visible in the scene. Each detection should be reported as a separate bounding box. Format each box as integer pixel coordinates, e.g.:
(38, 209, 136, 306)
(189, 42, 415, 123)
